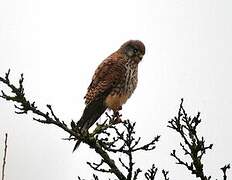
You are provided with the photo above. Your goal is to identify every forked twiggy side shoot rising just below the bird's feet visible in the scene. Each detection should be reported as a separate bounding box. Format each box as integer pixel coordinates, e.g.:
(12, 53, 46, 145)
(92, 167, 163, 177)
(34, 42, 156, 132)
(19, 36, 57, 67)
(94, 120, 160, 180)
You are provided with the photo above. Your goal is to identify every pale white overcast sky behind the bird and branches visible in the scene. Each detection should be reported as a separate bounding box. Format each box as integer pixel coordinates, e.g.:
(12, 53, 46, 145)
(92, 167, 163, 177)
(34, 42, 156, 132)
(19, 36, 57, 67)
(0, 0, 232, 180)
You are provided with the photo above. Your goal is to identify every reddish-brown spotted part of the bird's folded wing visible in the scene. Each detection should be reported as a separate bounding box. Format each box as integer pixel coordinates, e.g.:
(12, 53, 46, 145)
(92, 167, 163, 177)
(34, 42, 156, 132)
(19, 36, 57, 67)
(85, 54, 126, 104)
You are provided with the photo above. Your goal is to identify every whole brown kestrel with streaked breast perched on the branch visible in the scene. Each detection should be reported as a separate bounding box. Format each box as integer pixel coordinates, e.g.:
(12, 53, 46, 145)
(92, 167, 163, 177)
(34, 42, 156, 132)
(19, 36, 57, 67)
(73, 40, 145, 151)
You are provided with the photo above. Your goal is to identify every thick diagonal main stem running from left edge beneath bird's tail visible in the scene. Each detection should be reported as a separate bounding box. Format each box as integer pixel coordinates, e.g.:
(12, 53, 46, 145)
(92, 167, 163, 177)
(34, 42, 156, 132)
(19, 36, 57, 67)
(0, 70, 126, 180)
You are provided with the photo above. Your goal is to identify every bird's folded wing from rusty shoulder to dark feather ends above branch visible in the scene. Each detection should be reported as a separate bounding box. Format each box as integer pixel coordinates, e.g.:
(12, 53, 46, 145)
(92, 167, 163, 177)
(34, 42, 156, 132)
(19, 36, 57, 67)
(74, 56, 126, 135)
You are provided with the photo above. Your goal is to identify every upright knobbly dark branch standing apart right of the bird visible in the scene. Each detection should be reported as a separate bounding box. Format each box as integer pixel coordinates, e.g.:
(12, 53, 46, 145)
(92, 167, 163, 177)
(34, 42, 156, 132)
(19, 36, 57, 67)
(168, 99, 213, 180)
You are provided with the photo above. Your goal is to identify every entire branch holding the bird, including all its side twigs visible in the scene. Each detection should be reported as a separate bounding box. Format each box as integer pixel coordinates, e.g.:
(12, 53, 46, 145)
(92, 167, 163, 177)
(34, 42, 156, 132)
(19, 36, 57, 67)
(0, 70, 165, 180)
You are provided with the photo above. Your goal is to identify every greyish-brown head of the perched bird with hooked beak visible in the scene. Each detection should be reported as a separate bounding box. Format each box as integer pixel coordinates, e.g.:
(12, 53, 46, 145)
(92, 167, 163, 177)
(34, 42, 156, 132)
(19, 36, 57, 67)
(120, 40, 145, 63)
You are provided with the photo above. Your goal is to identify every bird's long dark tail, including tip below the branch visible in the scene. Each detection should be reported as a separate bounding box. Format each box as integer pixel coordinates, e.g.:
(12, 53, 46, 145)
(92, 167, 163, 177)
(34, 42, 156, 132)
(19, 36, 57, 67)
(73, 98, 107, 152)
